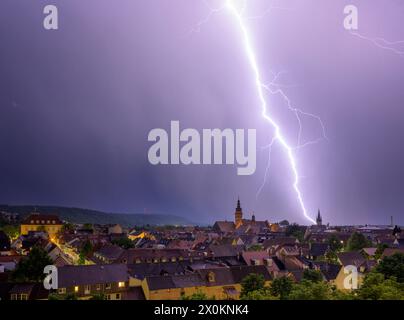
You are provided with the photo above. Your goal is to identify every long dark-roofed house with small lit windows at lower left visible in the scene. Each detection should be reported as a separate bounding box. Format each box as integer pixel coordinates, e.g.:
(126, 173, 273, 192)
(57, 264, 129, 300)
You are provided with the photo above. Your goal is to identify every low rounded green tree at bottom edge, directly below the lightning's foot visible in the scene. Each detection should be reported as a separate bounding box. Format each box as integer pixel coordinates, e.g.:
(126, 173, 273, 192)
(288, 280, 333, 300)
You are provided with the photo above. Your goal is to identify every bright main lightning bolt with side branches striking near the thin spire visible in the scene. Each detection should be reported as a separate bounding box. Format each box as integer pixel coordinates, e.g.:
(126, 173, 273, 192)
(191, 0, 327, 224)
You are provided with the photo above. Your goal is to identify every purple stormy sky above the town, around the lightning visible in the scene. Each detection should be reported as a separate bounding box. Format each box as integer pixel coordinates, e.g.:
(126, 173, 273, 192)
(0, 0, 404, 224)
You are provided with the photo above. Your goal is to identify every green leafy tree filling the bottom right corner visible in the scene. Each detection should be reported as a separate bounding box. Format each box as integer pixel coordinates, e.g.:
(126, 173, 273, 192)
(358, 272, 404, 300)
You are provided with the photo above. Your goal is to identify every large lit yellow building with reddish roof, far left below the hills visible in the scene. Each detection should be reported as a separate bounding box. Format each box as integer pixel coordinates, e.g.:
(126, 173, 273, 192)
(20, 213, 63, 237)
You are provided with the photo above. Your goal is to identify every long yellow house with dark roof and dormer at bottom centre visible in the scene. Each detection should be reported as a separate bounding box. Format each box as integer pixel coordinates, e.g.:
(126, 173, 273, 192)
(142, 266, 272, 300)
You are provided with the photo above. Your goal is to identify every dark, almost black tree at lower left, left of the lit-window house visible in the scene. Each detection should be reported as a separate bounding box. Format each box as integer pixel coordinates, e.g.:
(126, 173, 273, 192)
(12, 246, 53, 282)
